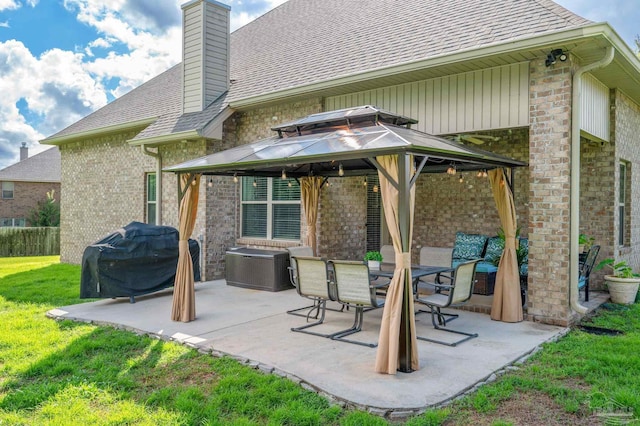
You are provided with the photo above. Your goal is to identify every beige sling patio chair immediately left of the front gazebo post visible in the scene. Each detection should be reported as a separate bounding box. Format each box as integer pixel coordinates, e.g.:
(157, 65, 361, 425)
(329, 260, 389, 348)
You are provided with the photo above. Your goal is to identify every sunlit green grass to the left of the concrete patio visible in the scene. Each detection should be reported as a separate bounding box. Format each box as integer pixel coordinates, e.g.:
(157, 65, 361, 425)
(0, 257, 384, 425)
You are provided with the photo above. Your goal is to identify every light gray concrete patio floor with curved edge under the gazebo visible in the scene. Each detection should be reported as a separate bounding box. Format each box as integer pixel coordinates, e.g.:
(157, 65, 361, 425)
(48, 280, 567, 418)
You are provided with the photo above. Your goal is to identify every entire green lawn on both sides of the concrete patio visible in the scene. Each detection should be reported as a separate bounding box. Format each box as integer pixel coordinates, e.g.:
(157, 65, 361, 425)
(0, 257, 640, 425)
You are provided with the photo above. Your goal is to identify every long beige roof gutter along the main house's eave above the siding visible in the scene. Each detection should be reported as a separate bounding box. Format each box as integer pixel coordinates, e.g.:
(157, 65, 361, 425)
(229, 23, 640, 108)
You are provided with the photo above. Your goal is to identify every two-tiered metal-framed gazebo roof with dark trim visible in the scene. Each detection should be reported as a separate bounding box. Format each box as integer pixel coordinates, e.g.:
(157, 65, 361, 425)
(164, 106, 527, 177)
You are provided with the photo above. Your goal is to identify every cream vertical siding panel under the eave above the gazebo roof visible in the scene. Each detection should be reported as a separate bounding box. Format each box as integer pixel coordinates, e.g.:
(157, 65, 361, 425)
(326, 62, 529, 135)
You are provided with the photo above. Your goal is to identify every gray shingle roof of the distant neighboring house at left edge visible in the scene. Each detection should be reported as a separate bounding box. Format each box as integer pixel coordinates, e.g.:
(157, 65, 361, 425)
(0, 147, 60, 182)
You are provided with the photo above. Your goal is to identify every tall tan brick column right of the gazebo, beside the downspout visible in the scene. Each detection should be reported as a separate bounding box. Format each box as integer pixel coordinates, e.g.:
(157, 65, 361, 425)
(528, 58, 571, 324)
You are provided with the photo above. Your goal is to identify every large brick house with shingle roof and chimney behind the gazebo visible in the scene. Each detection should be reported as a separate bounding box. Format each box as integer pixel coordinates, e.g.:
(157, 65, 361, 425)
(43, 0, 640, 324)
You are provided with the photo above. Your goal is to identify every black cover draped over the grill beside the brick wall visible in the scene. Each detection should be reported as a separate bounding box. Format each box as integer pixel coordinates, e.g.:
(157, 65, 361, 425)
(80, 222, 200, 298)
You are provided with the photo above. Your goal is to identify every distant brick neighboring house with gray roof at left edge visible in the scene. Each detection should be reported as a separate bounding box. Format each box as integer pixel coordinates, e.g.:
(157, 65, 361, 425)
(0, 143, 60, 227)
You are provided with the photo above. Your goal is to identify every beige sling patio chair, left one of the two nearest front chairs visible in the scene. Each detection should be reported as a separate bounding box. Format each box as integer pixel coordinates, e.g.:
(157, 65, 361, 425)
(291, 256, 332, 337)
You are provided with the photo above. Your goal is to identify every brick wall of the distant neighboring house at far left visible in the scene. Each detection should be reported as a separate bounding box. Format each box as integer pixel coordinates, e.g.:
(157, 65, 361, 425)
(0, 182, 60, 226)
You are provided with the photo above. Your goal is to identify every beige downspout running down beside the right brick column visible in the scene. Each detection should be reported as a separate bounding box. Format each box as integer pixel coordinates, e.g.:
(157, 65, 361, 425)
(569, 46, 615, 314)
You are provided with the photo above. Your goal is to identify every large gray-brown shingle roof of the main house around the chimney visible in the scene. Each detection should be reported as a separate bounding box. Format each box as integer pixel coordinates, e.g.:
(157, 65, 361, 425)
(45, 0, 591, 144)
